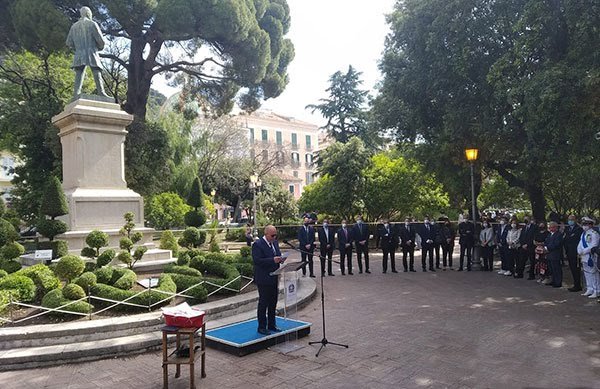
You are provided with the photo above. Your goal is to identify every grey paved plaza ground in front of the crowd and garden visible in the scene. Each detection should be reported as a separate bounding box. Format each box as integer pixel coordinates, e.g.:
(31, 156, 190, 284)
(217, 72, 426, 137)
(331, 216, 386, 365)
(0, 250, 600, 389)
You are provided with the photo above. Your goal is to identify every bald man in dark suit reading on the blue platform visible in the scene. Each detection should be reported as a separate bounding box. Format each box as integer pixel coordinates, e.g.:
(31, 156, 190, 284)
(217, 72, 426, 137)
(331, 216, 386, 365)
(252, 226, 284, 335)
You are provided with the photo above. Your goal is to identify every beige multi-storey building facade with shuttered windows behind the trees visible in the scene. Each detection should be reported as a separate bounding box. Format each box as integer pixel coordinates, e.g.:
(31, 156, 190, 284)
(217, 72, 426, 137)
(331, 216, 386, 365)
(235, 110, 319, 199)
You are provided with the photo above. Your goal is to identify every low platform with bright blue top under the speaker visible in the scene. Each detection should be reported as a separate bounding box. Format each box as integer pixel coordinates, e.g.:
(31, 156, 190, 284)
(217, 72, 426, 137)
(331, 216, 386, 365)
(206, 317, 311, 357)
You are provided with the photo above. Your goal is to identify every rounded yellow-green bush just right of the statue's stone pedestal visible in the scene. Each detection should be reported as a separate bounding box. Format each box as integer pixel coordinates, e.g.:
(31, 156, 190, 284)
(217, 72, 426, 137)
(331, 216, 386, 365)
(145, 192, 190, 230)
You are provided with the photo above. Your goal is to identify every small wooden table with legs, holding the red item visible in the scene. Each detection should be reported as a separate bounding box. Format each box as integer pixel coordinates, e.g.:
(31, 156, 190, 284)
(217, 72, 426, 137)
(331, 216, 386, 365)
(161, 324, 206, 389)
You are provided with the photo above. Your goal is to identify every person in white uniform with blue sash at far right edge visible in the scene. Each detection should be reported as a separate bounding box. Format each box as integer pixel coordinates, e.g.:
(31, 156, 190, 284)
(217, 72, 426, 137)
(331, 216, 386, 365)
(577, 217, 600, 298)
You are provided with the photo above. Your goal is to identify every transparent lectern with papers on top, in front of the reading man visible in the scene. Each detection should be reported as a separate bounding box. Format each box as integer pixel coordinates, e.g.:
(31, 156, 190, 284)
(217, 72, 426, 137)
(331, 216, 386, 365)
(271, 262, 306, 353)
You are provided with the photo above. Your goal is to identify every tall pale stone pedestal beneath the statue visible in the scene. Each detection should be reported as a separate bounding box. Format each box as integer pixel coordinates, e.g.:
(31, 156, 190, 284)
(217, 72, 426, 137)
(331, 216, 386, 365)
(52, 96, 164, 255)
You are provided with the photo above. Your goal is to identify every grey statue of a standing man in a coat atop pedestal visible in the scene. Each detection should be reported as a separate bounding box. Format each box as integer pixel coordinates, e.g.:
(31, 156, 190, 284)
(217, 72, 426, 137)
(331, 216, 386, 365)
(67, 7, 109, 97)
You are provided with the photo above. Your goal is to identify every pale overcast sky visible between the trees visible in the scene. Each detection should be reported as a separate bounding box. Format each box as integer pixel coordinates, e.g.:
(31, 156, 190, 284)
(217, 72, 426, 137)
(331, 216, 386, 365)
(155, 0, 395, 125)
